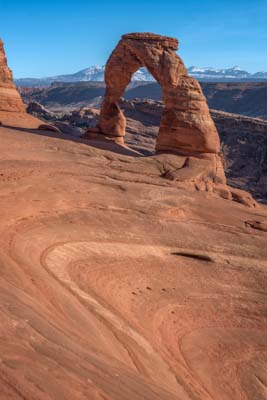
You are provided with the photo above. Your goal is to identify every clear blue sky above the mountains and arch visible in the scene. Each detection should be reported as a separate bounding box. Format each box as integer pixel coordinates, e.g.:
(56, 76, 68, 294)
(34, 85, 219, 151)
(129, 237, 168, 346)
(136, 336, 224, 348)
(0, 0, 267, 78)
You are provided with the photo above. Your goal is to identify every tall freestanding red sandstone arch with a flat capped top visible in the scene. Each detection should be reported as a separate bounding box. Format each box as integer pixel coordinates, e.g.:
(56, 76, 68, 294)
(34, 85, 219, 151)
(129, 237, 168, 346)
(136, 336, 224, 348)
(89, 33, 220, 155)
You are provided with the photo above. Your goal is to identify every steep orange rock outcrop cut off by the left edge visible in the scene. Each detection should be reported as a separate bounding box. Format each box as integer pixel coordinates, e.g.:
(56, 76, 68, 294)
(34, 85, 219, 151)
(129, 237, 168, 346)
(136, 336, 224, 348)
(0, 39, 25, 112)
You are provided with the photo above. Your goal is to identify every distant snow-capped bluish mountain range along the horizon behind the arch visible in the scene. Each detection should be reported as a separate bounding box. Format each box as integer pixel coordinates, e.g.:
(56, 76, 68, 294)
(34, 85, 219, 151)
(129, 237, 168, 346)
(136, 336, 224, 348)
(15, 65, 267, 86)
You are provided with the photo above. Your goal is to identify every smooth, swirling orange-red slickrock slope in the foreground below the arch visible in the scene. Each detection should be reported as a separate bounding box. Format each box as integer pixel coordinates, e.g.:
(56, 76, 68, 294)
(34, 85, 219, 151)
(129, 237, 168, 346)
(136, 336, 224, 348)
(0, 122, 267, 400)
